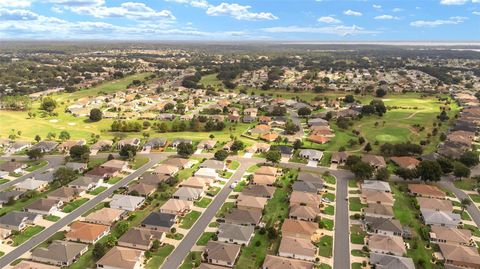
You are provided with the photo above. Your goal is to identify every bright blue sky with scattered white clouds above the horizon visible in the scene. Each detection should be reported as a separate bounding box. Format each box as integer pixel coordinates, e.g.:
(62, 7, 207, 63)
(0, 0, 480, 41)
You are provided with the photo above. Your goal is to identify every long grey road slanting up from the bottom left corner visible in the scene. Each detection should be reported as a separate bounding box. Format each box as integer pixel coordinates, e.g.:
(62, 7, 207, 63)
(0, 154, 168, 268)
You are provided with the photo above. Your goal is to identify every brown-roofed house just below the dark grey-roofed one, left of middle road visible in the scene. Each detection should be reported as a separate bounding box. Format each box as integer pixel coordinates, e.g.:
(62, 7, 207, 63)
(118, 228, 165, 251)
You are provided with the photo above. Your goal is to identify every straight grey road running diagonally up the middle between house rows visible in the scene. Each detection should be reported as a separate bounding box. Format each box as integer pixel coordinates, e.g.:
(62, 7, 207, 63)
(160, 159, 259, 269)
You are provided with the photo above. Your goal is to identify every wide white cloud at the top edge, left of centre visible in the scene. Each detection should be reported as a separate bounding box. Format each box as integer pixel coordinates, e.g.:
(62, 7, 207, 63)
(70, 2, 175, 21)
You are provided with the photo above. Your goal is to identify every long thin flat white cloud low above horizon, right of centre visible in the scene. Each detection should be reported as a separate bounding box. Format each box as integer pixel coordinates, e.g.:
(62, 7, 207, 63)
(263, 25, 378, 36)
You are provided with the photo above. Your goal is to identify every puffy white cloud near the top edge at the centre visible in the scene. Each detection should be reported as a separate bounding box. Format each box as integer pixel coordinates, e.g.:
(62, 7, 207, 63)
(207, 3, 278, 21)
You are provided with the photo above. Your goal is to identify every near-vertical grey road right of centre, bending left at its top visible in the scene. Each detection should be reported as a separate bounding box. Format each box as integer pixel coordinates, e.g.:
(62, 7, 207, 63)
(280, 163, 353, 269)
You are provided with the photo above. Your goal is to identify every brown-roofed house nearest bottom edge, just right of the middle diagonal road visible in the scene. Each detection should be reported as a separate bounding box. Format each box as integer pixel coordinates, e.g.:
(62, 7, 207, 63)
(203, 241, 241, 267)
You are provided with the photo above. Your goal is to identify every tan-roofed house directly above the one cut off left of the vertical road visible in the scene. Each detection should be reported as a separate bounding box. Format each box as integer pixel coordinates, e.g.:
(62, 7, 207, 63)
(278, 236, 317, 262)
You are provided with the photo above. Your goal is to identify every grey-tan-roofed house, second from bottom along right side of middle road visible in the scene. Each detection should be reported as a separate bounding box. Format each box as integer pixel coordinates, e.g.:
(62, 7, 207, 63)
(217, 223, 255, 245)
